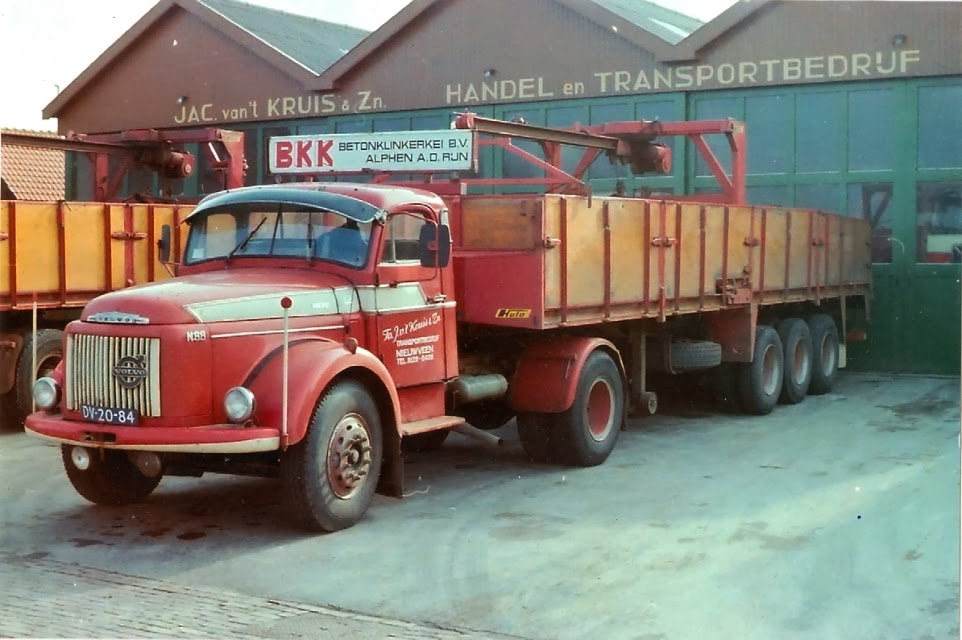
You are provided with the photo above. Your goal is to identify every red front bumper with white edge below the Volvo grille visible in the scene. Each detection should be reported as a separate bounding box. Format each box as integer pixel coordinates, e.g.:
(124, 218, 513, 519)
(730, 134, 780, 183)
(25, 412, 281, 453)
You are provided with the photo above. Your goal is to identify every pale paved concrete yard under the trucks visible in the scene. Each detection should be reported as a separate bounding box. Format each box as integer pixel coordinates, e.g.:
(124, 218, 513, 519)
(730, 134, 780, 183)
(0, 374, 960, 640)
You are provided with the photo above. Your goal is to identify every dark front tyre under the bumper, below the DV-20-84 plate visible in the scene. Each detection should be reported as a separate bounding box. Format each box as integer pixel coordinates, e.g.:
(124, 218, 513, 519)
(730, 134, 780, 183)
(60, 445, 163, 506)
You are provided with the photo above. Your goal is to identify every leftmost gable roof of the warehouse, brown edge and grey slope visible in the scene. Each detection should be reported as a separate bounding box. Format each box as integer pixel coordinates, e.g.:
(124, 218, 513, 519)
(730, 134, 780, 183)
(43, 0, 368, 118)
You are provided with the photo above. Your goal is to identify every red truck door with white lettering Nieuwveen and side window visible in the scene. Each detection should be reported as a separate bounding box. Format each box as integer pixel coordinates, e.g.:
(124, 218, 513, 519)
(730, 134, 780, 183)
(373, 212, 457, 388)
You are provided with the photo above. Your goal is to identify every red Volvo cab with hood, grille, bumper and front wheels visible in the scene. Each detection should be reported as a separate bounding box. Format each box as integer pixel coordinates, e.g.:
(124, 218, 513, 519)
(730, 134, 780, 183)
(27, 183, 463, 530)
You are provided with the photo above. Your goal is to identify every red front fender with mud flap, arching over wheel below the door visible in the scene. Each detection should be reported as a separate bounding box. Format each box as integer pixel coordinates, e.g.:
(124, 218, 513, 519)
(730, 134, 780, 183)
(244, 338, 403, 496)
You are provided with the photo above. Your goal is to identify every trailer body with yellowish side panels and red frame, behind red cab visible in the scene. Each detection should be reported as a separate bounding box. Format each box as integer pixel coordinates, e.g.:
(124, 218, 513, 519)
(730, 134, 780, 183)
(452, 195, 871, 329)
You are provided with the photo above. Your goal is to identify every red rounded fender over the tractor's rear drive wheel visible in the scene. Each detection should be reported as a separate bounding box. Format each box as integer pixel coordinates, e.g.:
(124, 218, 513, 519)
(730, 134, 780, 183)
(508, 336, 625, 413)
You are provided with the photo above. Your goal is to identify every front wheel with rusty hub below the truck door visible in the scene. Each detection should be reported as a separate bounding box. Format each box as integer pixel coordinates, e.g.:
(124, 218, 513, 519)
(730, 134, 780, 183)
(281, 380, 383, 531)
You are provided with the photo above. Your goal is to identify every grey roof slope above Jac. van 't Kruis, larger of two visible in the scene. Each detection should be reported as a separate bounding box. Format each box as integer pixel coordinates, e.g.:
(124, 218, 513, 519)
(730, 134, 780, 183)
(200, 0, 369, 73)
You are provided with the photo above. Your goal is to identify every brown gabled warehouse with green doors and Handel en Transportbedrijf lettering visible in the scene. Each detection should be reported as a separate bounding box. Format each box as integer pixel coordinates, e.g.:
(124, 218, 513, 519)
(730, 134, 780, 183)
(44, 0, 962, 373)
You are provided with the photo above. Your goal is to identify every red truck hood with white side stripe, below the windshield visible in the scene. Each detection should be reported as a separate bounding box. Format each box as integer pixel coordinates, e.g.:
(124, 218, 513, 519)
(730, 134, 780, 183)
(81, 269, 357, 325)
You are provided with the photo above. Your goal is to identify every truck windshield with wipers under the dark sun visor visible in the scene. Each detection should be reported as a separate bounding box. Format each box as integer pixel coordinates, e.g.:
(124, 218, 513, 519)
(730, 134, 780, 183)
(184, 203, 372, 269)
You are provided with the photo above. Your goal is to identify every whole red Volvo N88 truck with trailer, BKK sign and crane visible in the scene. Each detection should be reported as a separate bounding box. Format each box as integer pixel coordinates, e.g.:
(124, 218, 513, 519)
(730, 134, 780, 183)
(27, 114, 871, 531)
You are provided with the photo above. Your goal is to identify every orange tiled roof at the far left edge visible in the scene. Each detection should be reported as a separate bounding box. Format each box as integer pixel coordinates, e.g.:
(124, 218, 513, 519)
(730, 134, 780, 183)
(0, 129, 66, 200)
